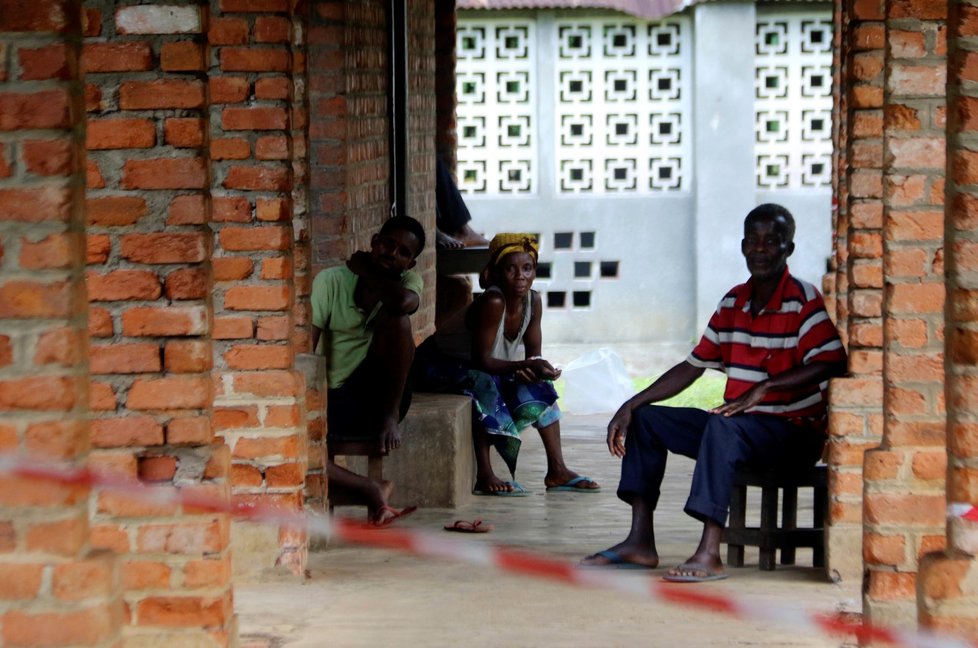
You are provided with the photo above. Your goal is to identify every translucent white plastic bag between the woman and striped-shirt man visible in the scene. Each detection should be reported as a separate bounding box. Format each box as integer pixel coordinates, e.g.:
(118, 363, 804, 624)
(560, 347, 635, 414)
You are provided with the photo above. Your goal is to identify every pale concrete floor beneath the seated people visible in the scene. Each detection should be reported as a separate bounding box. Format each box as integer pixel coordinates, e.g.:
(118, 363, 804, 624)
(235, 408, 860, 648)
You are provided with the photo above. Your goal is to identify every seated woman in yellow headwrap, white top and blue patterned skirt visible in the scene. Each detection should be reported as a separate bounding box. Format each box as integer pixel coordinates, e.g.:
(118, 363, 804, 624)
(413, 233, 599, 497)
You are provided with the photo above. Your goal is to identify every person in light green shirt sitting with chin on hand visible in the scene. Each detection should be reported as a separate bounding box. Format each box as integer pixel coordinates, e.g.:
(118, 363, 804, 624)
(311, 216, 425, 526)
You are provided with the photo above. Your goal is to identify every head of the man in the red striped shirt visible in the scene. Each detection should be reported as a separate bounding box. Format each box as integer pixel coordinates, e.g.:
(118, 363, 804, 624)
(740, 203, 795, 281)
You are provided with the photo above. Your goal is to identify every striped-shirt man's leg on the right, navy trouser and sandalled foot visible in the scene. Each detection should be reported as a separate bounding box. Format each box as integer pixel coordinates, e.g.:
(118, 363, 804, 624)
(667, 414, 824, 580)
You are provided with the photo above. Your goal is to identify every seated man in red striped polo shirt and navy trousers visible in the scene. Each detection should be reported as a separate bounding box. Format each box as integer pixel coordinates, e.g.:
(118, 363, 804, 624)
(581, 204, 847, 582)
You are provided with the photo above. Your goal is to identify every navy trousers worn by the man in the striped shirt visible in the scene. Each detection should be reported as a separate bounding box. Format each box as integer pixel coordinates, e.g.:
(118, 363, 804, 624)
(618, 405, 825, 525)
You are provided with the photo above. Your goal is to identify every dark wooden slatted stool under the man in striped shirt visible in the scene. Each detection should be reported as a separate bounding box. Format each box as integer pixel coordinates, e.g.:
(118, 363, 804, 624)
(723, 464, 828, 571)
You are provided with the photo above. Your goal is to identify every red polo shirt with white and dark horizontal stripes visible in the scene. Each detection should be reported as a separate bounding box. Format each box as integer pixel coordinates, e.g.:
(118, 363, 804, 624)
(686, 268, 846, 429)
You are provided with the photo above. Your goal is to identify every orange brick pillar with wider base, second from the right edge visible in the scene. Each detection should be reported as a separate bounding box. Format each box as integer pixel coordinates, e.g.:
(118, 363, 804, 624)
(863, 2, 947, 628)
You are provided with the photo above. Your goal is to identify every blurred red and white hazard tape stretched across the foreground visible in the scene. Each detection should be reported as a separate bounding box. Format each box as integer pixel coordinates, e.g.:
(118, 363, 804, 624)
(0, 453, 978, 648)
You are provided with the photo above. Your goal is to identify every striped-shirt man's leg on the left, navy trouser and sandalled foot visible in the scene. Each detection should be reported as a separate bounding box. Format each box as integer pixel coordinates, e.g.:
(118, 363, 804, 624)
(581, 405, 709, 567)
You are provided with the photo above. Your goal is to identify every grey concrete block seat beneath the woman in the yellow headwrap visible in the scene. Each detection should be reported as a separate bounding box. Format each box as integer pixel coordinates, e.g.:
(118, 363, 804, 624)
(337, 392, 475, 508)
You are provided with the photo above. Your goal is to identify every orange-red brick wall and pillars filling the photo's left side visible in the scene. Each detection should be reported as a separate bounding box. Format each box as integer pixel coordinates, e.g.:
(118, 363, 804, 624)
(0, 0, 436, 645)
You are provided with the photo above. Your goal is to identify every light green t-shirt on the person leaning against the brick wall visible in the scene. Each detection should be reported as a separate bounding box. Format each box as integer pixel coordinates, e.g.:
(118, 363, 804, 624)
(311, 265, 424, 388)
